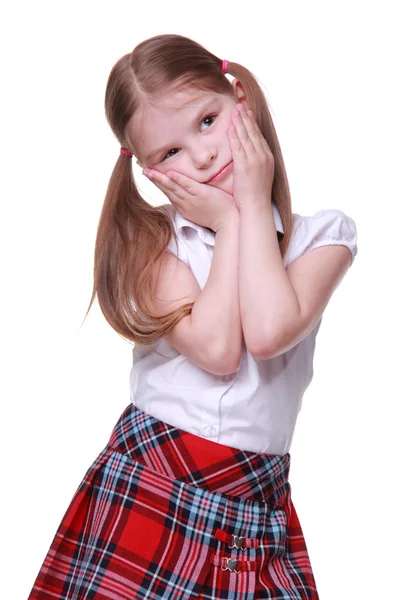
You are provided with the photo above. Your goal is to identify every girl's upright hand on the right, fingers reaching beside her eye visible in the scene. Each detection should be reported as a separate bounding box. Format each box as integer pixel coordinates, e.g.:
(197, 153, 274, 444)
(228, 103, 275, 210)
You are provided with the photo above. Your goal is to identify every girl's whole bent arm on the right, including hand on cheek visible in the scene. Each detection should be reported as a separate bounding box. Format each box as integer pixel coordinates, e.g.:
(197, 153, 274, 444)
(229, 104, 351, 359)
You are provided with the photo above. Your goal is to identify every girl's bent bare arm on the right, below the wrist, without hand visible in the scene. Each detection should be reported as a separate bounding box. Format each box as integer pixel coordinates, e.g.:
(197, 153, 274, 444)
(239, 200, 351, 359)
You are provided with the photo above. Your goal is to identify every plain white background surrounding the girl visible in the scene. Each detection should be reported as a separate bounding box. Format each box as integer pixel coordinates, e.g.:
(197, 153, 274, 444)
(0, 0, 400, 600)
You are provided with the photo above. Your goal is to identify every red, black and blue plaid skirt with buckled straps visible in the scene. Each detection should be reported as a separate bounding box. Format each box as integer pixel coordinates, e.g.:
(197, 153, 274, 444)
(28, 404, 319, 600)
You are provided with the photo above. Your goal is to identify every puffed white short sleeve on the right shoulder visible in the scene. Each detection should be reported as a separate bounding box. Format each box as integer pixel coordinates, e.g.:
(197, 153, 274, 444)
(284, 209, 358, 268)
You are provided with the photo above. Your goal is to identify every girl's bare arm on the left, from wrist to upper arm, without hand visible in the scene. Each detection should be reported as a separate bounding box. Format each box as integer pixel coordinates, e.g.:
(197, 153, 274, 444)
(155, 210, 242, 375)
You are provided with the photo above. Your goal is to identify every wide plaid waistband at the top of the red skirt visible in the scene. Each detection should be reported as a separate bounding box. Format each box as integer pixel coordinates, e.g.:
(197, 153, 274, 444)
(108, 403, 291, 506)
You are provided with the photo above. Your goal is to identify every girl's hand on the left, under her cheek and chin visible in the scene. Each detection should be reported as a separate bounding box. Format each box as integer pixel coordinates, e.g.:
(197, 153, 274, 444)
(143, 168, 237, 232)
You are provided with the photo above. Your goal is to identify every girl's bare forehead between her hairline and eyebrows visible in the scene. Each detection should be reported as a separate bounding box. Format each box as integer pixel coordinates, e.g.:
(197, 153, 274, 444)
(129, 90, 222, 158)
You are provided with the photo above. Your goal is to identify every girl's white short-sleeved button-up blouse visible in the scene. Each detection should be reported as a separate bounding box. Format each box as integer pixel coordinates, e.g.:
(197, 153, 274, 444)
(130, 204, 357, 455)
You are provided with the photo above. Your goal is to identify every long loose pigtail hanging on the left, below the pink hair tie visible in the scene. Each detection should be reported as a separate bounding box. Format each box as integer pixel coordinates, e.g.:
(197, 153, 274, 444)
(85, 153, 193, 345)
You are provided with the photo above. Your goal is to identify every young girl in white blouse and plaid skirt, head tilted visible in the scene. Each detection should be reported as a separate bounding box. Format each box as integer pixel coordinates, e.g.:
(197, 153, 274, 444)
(29, 35, 357, 600)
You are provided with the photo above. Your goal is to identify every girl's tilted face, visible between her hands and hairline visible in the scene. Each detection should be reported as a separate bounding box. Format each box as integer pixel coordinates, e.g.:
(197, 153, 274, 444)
(128, 90, 238, 194)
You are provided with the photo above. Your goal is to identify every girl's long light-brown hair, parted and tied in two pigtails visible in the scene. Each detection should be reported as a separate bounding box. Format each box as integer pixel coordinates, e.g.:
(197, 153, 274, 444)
(85, 34, 292, 344)
